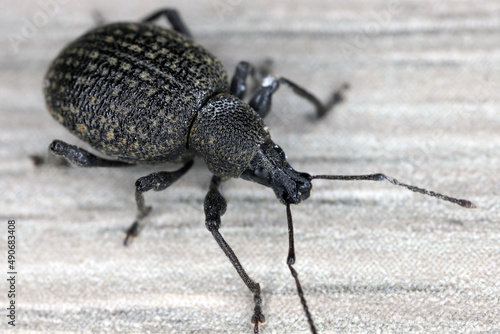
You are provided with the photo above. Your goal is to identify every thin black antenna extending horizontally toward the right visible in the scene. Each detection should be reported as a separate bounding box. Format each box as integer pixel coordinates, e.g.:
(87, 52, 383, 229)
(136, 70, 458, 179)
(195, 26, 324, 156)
(311, 173, 476, 209)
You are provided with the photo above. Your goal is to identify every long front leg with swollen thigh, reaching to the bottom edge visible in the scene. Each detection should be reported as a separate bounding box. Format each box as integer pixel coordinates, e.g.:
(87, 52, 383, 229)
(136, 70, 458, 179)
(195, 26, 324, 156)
(204, 176, 266, 333)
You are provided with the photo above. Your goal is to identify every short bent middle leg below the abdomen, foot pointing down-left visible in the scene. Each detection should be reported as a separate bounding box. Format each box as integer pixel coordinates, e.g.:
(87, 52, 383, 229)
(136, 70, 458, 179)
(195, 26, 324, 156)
(123, 160, 193, 246)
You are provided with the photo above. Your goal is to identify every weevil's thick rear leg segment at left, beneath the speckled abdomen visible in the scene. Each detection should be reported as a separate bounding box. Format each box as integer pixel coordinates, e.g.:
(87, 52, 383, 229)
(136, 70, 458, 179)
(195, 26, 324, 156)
(49, 140, 133, 167)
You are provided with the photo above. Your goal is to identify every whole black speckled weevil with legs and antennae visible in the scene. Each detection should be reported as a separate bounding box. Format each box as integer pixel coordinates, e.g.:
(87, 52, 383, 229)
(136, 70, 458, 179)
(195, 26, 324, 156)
(44, 9, 475, 333)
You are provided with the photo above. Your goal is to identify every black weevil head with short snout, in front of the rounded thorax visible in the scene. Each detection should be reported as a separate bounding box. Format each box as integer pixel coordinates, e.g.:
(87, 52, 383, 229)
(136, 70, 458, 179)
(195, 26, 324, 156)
(240, 139, 312, 204)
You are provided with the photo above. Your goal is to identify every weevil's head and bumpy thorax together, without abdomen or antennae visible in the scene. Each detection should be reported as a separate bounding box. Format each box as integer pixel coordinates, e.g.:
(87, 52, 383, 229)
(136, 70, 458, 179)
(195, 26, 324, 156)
(188, 93, 312, 204)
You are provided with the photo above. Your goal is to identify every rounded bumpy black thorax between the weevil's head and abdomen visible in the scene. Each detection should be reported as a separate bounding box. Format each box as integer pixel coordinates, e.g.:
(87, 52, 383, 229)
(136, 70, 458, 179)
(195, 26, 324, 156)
(189, 93, 269, 179)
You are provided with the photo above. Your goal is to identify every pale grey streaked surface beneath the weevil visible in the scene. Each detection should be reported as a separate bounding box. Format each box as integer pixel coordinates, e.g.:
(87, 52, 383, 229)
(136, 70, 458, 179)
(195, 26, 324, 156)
(0, 0, 500, 333)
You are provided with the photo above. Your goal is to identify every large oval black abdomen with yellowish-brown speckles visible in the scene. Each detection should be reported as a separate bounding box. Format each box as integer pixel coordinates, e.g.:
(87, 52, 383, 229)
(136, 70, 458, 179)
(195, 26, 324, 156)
(45, 23, 227, 163)
